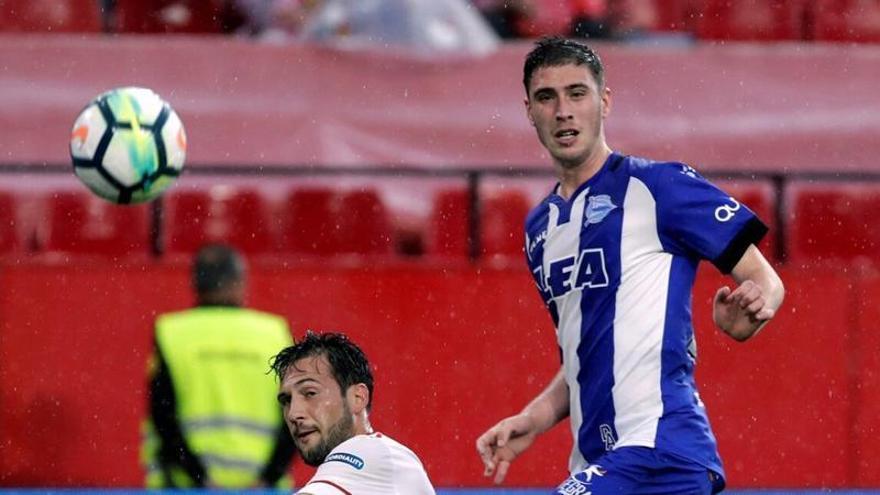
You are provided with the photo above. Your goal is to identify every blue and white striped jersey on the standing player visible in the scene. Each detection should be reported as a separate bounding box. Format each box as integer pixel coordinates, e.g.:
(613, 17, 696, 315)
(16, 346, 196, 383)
(526, 153, 767, 474)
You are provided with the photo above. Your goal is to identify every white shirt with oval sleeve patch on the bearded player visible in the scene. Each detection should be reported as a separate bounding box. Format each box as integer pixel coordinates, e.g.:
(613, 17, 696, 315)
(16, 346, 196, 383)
(297, 433, 436, 495)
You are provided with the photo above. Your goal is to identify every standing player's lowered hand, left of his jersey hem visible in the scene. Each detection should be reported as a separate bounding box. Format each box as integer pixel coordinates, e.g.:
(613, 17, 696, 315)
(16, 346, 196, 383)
(477, 414, 538, 485)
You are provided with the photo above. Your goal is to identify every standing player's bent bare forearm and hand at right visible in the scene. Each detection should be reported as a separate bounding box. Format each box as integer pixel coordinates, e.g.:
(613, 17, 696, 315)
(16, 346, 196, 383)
(712, 245, 785, 342)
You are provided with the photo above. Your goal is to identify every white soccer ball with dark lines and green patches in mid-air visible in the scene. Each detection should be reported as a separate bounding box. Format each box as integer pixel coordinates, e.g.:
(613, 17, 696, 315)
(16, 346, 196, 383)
(70, 87, 186, 204)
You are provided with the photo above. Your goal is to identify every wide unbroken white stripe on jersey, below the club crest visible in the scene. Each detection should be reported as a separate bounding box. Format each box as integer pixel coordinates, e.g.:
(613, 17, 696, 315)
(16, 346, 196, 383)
(612, 177, 672, 448)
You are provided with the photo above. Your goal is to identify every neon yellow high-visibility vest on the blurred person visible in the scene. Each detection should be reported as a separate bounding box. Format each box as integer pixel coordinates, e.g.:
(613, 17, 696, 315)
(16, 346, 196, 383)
(142, 307, 293, 488)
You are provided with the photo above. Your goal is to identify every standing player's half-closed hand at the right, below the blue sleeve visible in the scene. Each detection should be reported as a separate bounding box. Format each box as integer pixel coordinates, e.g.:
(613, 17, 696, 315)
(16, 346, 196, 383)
(712, 280, 776, 341)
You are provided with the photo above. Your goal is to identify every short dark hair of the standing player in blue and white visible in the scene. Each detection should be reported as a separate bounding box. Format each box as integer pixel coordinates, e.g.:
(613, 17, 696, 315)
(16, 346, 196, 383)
(523, 36, 605, 96)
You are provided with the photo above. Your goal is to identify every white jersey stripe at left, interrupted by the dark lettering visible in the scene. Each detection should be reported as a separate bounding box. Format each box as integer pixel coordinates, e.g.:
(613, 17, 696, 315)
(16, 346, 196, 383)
(543, 187, 590, 472)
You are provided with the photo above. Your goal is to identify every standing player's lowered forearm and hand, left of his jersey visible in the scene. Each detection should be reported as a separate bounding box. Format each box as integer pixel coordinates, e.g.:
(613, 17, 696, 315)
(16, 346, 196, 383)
(477, 369, 569, 484)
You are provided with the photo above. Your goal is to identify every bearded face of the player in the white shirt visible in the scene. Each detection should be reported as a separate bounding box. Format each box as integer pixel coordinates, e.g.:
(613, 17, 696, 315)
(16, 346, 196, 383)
(278, 355, 354, 466)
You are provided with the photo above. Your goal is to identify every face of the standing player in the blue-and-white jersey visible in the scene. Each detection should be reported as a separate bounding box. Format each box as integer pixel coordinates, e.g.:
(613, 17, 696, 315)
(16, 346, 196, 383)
(525, 64, 611, 169)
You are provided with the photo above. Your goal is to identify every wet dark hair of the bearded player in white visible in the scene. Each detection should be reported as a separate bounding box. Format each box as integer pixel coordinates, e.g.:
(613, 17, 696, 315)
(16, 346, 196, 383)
(270, 330, 373, 411)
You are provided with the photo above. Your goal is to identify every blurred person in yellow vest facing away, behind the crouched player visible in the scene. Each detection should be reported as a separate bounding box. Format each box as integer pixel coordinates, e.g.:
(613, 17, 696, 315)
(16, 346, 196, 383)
(142, 244, 295, 488)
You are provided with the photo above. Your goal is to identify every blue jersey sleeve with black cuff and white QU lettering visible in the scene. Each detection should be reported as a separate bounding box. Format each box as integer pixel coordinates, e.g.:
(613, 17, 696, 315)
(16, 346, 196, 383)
(653, 163, 768, 273)
